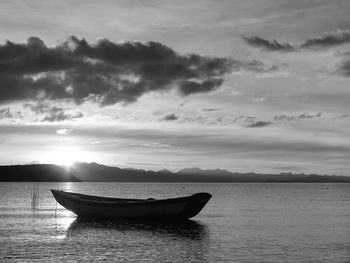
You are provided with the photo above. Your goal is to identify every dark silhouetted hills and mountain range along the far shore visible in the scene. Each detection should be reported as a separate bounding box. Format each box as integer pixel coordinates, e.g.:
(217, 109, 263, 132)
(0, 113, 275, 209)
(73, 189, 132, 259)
(0, 163, 350, 183)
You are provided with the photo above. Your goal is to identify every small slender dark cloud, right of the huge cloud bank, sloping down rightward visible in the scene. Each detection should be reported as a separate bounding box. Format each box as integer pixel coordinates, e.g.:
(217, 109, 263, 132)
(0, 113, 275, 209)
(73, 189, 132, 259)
(242, 36, 295, 52)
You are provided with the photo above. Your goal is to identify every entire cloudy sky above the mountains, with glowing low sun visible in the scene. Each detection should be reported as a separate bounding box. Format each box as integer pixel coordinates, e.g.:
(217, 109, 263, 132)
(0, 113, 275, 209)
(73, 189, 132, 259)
(0, 0, 350, 176)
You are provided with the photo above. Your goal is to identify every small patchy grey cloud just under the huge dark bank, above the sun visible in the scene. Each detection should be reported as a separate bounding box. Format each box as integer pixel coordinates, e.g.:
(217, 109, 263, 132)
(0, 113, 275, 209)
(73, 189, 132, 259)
(24, 102, 84, 122)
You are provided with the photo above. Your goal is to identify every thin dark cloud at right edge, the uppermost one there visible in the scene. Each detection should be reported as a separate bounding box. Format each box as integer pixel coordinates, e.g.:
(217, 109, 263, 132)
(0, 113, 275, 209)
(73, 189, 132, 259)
(300, 29, 350, 48)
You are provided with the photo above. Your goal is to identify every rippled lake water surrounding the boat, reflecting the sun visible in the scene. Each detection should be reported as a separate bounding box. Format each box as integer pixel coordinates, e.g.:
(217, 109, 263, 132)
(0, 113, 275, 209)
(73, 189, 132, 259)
(0, 183, 350, 263)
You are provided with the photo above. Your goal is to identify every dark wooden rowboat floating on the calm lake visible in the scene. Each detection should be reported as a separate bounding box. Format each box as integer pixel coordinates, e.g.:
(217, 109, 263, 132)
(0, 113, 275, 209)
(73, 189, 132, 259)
(51, 190, 211, 220)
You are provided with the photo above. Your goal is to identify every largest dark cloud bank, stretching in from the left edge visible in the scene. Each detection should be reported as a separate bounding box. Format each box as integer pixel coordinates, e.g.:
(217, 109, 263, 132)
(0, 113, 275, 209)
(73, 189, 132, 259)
(0, 36, 273, 106)
